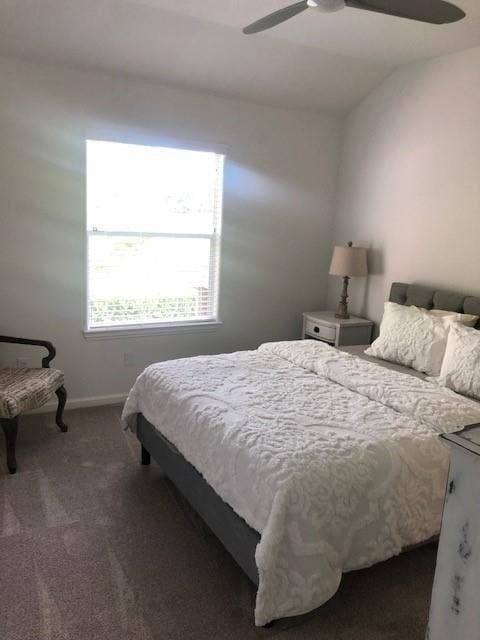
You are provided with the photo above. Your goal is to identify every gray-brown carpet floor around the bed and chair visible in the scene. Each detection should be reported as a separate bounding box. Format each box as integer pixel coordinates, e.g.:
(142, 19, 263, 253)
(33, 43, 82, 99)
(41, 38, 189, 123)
(0, 407, 436, 640)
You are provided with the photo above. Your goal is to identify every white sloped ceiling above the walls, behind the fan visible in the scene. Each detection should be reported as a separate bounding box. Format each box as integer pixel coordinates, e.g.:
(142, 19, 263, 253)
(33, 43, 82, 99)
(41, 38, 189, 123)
(0, 0, 480, 112)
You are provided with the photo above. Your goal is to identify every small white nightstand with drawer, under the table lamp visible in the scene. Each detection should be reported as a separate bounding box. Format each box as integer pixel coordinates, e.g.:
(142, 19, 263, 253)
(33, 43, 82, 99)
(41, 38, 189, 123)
(302, 311, 373, 347)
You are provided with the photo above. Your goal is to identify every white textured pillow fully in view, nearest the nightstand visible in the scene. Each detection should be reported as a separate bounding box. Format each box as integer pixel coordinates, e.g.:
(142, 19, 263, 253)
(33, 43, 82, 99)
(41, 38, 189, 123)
(365, 302, 464, 376)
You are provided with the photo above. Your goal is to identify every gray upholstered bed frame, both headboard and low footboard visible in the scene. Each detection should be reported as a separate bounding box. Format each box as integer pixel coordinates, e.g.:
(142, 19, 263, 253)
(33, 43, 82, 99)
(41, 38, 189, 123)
(137, 282, 480, 600)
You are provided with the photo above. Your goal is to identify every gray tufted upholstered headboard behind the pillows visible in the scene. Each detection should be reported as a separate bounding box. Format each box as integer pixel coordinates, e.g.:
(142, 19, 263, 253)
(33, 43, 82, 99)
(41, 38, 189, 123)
(389, 282, 480, 329)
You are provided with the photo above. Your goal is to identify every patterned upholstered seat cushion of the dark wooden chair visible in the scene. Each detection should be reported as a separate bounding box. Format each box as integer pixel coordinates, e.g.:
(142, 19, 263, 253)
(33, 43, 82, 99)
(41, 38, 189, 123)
(0, 368, 64, 418)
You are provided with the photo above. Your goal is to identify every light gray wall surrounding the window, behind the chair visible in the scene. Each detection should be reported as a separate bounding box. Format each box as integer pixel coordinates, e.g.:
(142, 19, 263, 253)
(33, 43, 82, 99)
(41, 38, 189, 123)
(0, 60, 338, 399)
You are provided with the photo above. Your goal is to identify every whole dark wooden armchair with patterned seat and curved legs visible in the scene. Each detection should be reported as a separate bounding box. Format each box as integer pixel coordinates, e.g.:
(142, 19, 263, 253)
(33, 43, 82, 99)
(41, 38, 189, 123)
(0, 336, 68, 473)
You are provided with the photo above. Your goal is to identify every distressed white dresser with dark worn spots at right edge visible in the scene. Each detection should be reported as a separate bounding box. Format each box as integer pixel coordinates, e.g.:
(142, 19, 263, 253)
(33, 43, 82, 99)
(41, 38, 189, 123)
(427, 424, 480, 640)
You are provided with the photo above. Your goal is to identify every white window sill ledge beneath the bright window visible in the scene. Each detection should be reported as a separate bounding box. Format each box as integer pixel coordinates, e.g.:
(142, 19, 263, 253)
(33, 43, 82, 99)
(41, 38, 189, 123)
(83, 320, 223, 340)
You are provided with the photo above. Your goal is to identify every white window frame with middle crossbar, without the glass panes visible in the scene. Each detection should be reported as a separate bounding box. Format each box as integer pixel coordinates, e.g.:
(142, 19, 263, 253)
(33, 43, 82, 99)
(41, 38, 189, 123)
(83, 136, 226, 340)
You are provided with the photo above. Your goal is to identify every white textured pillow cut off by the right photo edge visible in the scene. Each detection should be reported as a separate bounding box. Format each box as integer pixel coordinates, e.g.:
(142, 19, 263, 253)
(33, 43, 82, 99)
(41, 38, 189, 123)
(438, 324, 480, 400)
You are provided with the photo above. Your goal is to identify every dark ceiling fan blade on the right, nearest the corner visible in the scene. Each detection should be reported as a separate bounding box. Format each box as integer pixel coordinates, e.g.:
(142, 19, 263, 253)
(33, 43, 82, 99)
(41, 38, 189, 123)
(345, 0, 466, 24)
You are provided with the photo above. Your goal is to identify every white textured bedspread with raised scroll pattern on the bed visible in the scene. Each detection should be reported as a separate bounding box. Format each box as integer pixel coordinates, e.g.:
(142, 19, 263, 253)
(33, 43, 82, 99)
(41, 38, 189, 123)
(123, 340, 480, 625)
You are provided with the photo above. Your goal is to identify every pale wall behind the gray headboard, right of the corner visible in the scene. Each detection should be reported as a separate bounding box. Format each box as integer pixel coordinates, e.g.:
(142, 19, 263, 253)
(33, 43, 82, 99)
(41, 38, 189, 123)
(328, 48, 480, 321)
